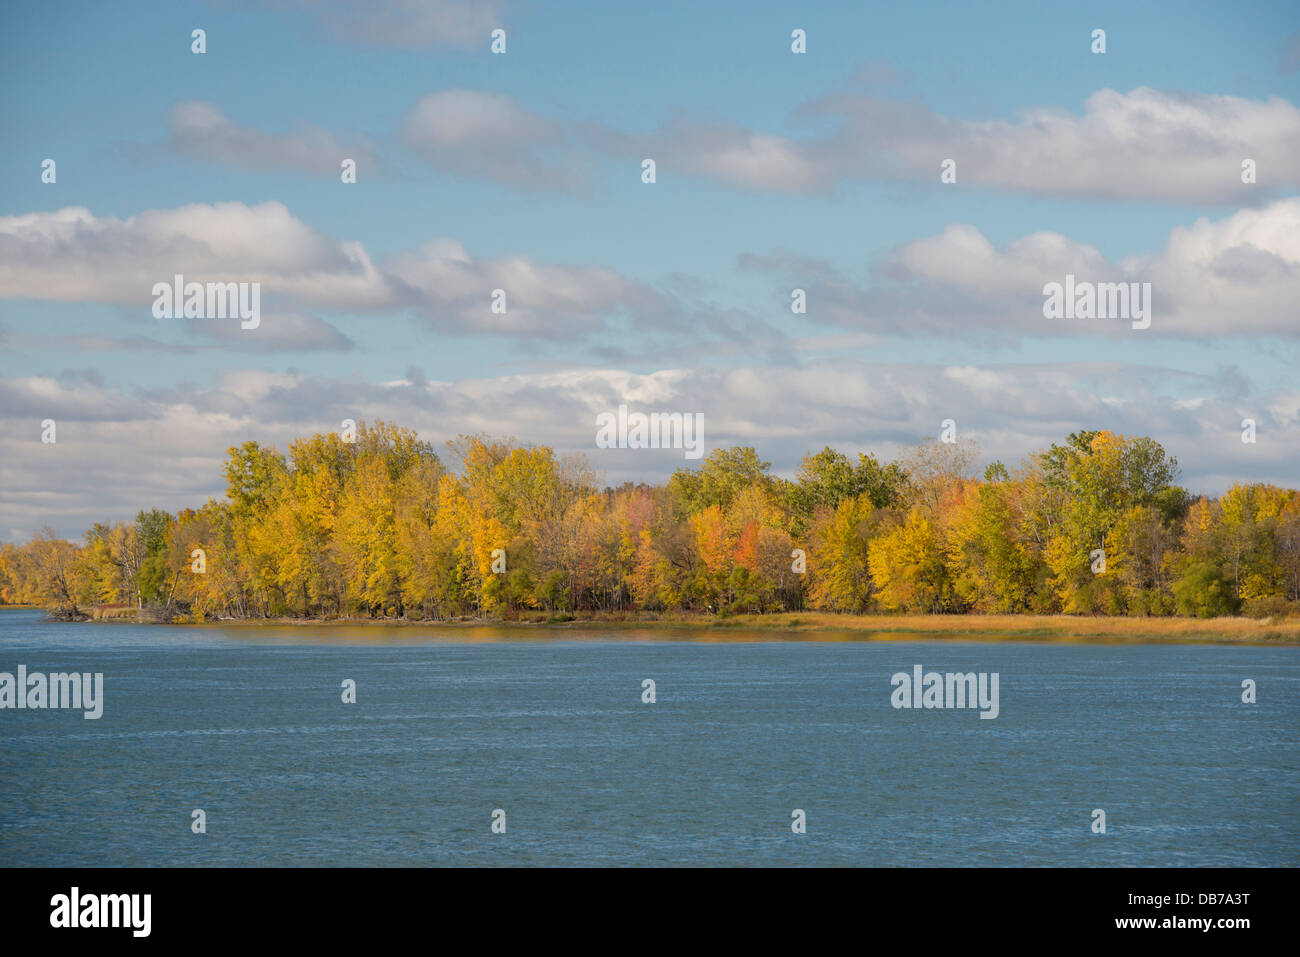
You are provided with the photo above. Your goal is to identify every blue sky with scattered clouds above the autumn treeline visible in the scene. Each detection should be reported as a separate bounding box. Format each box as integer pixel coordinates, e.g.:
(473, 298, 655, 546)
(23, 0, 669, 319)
(0, 0, 1300, 541)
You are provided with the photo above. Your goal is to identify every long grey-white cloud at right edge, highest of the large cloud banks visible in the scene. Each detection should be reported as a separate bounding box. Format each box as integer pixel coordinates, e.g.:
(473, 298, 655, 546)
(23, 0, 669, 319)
(616, 87, 1300, 204)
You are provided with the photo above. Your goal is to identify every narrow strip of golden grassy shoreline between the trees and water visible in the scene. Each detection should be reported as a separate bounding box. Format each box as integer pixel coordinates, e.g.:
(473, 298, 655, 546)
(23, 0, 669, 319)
(10, 606, 1300, 645)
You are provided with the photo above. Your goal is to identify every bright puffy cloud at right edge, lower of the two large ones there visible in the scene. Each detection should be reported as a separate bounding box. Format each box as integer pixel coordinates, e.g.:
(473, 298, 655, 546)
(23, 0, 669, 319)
(740, 198, 1300, 338)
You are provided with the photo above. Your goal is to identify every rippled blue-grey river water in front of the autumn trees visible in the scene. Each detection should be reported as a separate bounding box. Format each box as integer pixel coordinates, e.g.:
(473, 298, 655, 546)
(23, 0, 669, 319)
(0, 610, 1300, 866)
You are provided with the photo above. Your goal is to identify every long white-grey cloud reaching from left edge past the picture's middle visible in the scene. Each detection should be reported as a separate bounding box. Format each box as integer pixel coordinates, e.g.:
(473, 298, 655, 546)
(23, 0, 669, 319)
(0, 203, 680, 350)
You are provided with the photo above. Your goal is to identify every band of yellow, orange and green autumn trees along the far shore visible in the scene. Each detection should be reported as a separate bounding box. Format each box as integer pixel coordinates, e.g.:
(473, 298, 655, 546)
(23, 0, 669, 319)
(0, 423, 1300, 622)
